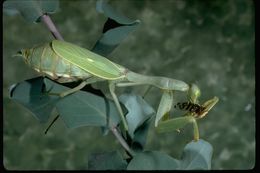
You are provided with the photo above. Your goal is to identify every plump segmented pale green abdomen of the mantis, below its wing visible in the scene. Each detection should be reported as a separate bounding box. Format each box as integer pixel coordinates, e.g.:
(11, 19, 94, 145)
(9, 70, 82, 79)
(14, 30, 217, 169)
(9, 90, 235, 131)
(22, 43, 92, 83)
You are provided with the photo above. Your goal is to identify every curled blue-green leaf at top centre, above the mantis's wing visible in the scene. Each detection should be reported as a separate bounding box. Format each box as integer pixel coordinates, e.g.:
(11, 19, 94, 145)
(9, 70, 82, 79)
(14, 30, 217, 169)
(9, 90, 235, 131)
(92, 0, 140, 56)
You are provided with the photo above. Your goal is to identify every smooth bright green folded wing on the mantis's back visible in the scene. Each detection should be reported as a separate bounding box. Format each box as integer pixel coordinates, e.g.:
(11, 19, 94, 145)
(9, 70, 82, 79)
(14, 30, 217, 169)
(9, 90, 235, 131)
(52, 40, 125, 80)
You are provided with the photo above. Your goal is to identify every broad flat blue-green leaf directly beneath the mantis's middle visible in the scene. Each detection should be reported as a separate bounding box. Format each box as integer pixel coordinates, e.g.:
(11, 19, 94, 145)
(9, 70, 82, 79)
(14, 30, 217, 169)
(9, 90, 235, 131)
(46, 79, 120, 128)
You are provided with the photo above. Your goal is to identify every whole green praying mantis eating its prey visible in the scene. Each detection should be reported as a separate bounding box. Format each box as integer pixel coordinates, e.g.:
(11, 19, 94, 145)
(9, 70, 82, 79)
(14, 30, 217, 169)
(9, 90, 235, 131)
(17, 40, 218, 139)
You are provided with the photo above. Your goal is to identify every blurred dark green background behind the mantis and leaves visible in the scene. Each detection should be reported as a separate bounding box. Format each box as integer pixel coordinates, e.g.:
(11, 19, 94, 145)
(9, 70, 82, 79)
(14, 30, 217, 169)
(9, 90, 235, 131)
(3, 0, 255, 170)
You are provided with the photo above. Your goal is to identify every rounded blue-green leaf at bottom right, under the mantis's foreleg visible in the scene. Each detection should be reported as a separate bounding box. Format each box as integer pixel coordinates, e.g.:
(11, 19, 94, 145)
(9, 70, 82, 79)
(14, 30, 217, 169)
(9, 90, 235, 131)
(180, 139, 213, 170)
